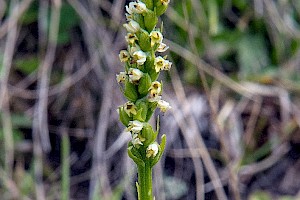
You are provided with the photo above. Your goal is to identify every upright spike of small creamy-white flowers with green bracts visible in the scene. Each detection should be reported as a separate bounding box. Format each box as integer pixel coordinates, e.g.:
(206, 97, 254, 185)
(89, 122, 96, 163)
(117, 0, 172, 165)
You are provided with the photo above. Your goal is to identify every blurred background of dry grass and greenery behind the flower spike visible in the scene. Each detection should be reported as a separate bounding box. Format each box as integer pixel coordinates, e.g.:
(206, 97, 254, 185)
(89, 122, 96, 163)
(0, 0, 300, 200)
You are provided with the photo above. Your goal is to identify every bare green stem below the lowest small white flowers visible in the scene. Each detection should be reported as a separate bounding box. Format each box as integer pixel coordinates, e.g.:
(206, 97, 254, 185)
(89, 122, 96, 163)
(138, 160, 153, 200)
